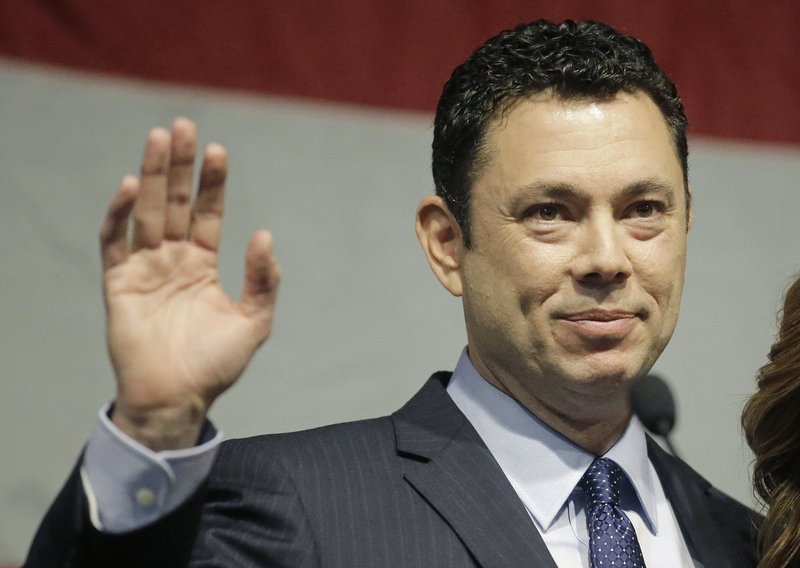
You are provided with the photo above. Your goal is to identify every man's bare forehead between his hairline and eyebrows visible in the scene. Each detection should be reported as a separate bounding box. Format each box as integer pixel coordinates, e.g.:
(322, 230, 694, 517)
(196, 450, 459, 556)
(473, 92, 683, 203)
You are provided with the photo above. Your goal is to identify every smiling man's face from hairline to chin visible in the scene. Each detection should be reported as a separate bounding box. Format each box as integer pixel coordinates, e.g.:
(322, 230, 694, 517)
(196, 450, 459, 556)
(459, 93, 688, 412)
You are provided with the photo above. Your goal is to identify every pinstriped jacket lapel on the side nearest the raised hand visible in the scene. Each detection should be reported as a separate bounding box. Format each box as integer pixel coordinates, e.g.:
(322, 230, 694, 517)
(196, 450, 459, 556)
(392, 373, 556, 568)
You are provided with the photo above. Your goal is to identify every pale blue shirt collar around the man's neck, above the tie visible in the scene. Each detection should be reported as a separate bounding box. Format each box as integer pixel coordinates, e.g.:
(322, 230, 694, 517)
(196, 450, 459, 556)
(447, 348, 658, 533)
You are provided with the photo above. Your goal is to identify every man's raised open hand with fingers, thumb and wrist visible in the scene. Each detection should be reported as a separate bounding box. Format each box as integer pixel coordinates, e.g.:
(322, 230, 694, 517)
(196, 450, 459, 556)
(100, 118, 280, 450)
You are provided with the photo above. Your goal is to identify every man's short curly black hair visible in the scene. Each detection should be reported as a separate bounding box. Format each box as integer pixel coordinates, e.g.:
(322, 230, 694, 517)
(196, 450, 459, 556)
(433, 20, 689, 247)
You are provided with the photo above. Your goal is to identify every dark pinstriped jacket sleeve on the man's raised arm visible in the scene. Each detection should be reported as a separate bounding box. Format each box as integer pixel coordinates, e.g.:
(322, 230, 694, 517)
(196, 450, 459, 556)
(25, 444, 318, 568)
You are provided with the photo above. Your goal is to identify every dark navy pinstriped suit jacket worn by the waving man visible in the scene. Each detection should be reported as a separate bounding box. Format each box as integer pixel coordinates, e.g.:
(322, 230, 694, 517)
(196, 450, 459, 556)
(27, 373, 758, 568)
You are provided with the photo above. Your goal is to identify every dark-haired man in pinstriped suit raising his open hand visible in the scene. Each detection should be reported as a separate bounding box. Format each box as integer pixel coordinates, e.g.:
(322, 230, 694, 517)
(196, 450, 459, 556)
(29, 21, 758, 568)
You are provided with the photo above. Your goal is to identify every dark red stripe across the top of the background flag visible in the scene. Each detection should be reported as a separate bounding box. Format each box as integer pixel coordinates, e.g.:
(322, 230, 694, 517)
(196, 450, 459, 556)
(0, 0, 800, 144)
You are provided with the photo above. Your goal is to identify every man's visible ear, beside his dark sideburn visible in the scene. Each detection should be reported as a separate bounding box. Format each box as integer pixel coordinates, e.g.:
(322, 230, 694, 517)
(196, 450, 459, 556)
(416, 195, 464, 296)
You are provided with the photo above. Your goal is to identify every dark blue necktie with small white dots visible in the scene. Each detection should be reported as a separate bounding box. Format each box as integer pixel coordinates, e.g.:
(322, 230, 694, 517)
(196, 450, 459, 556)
(580, 458, 645, 568)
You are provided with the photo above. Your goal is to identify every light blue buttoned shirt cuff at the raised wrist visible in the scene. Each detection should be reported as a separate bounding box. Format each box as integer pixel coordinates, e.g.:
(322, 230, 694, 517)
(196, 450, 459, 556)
(81, 404, 222, 533)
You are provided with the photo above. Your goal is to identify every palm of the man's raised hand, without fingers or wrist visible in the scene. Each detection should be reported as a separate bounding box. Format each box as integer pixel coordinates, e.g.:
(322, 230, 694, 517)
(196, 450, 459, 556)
(105, 241, 269, 410)
